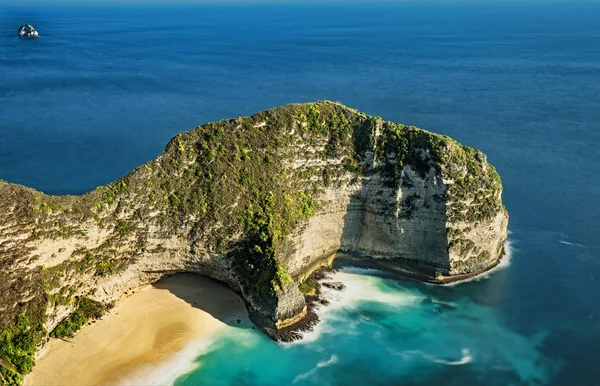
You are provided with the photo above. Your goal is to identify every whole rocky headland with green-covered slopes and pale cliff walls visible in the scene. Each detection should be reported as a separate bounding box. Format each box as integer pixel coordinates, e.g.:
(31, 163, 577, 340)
(0, 102, 508, 380)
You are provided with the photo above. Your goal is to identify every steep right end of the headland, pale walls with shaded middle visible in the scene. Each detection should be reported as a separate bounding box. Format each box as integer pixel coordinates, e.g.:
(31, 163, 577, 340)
(281, 112, 508, 282)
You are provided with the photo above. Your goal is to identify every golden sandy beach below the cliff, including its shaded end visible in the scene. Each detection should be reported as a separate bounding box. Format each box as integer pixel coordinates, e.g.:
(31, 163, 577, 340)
(25, 274, 248, 386)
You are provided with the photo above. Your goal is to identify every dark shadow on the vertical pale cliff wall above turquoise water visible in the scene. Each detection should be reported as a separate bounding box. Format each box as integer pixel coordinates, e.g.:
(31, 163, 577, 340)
(333, 123, 449, 281)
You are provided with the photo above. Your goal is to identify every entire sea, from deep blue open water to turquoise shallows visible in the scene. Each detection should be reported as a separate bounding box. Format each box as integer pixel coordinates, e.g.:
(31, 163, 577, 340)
(0, 1, 600, 386)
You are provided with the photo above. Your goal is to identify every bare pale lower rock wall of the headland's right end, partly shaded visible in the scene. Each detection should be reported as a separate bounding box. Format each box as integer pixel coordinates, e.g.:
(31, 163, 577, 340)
(285, 160, 508, 279)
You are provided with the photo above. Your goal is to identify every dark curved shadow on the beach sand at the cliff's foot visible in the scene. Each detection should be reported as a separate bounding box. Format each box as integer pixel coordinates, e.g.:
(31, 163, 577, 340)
(153, 272, 254, 328)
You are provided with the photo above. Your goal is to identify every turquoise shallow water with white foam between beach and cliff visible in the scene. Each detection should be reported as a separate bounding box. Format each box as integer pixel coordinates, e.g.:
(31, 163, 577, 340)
(175, 268, 560, 386)
